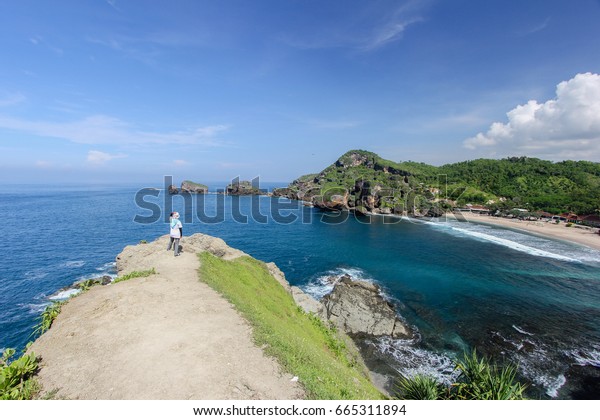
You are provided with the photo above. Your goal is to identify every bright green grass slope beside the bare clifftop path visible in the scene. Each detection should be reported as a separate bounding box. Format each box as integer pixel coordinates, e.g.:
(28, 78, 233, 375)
(200, 252, 383, 400)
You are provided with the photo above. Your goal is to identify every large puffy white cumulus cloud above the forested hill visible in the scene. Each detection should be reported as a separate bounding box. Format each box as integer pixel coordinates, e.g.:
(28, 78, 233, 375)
(463, 73, 600, 160)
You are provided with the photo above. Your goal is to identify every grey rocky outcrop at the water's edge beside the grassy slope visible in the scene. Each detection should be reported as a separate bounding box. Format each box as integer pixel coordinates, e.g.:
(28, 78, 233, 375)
(322, 275, 412, 338)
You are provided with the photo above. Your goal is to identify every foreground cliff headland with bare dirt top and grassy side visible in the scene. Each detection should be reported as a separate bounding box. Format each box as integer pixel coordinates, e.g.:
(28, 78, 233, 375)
(30, 234, 382, 399)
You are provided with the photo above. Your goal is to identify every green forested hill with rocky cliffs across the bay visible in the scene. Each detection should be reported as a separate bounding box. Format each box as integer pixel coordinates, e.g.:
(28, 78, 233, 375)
(276, 150, 600, 215)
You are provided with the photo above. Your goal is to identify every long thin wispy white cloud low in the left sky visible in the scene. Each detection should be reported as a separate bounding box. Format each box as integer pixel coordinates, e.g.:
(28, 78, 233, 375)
(0, 115, 229, 146)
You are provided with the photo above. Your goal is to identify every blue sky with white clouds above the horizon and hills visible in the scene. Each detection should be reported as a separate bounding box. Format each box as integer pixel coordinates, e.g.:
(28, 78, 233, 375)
(0, 0, 600, 184)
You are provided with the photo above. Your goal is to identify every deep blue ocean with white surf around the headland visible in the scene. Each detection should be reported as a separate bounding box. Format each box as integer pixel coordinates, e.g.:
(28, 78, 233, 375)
(0, 182, 600, 399)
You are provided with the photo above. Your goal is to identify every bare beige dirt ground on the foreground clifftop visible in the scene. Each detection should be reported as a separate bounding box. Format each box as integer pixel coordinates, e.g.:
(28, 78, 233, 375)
(31, 235, 303, 399)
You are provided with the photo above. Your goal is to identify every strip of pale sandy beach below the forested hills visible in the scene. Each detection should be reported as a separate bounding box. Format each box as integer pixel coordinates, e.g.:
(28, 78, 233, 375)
(450, 212, 600, 250)
